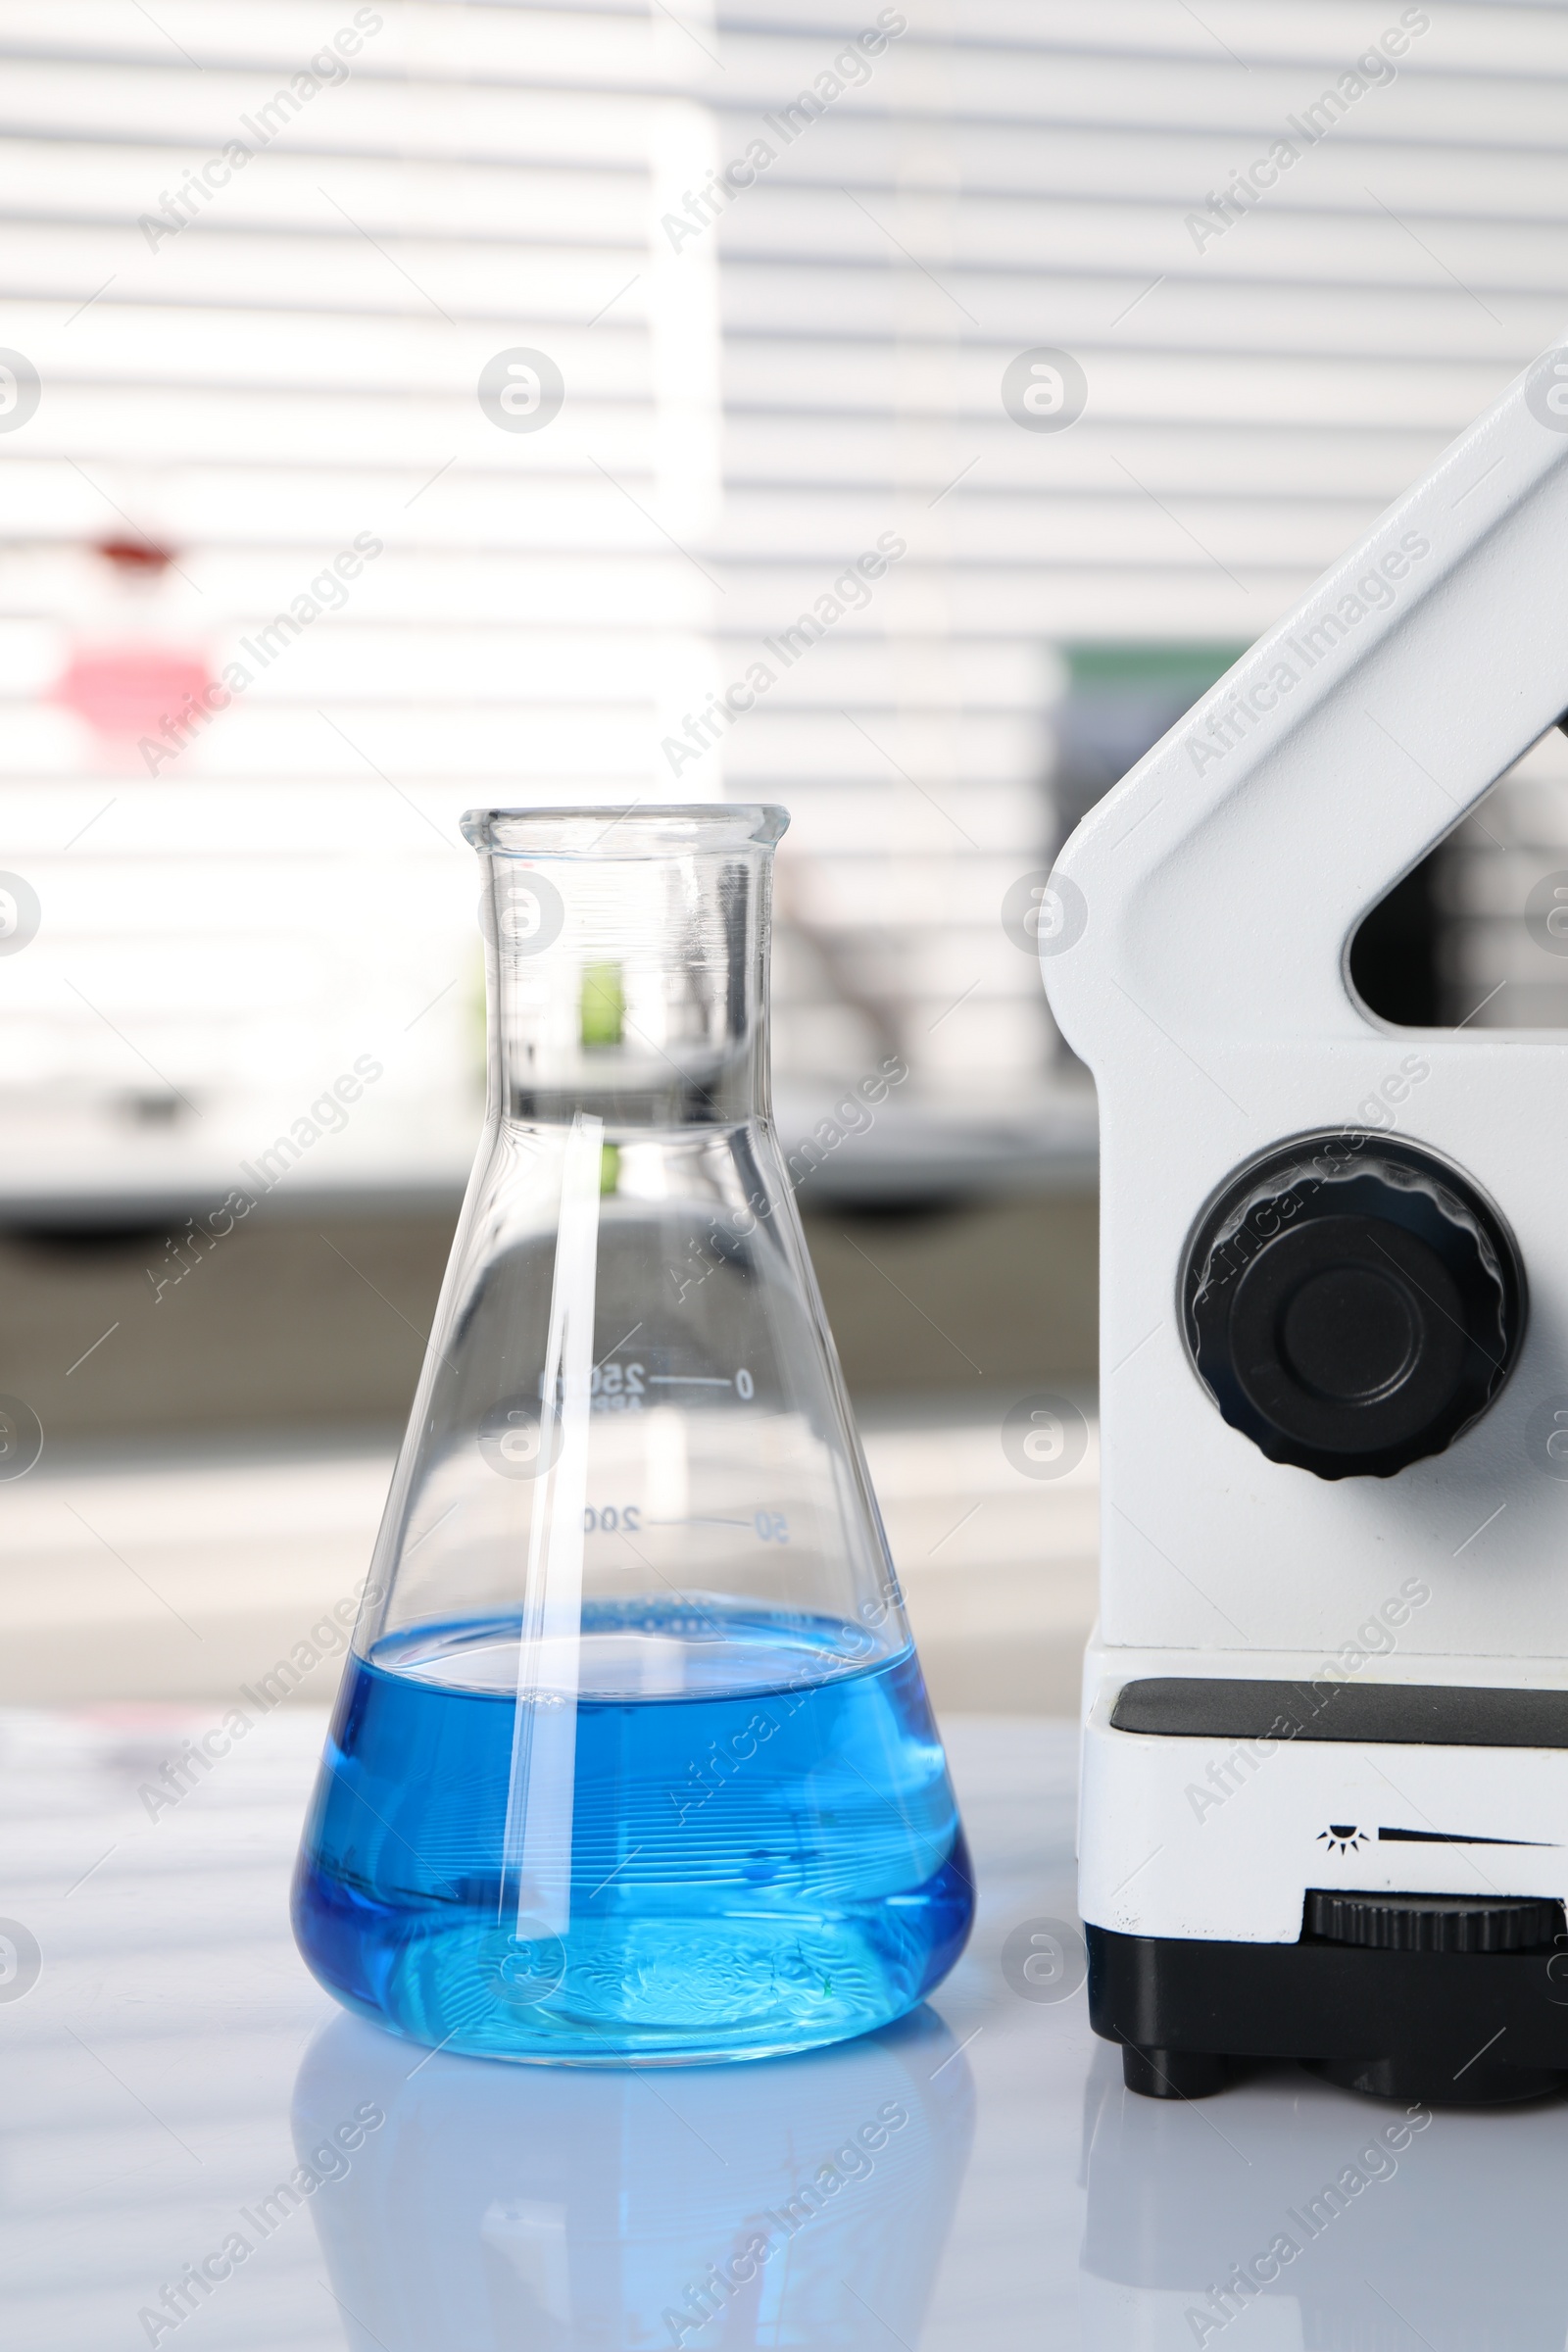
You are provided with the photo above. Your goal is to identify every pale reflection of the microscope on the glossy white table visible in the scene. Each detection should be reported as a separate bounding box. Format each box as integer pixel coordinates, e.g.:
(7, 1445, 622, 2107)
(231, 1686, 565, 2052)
(1079, 2051, 1568, 2352)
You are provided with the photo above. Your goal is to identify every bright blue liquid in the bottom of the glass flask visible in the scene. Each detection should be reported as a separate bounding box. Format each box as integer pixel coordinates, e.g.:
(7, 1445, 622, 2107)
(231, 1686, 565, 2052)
(294, 1601, 973, 2065)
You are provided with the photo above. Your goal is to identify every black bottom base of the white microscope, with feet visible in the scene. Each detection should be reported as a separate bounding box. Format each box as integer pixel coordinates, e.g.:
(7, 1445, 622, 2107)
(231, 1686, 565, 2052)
(1086, 1927, 1568, 2107)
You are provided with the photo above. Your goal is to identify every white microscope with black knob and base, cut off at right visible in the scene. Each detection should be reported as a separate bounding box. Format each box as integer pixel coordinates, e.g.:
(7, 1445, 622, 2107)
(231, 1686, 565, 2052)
(1039, 348, 1568, 2105)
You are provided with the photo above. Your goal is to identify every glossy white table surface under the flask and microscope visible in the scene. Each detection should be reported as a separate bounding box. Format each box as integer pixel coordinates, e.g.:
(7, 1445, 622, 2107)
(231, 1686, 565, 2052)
(0, 1707, 1568, 2352)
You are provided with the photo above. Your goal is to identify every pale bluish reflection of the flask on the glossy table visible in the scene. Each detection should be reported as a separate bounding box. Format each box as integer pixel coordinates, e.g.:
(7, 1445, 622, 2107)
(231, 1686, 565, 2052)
(294, 1966, 973, 2352)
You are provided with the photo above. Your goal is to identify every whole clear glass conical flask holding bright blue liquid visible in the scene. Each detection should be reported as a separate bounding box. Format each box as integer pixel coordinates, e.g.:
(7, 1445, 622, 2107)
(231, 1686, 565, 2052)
(294, 805, 973, 2065)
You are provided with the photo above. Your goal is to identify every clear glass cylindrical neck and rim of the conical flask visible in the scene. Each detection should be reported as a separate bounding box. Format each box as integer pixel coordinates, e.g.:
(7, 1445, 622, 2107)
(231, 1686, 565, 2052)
(464, 807, 783, 1129)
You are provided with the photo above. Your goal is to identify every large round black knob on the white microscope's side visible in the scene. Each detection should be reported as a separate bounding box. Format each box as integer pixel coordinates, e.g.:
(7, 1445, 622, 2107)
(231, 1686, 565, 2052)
(1183, 1129, 1526, 1477)
